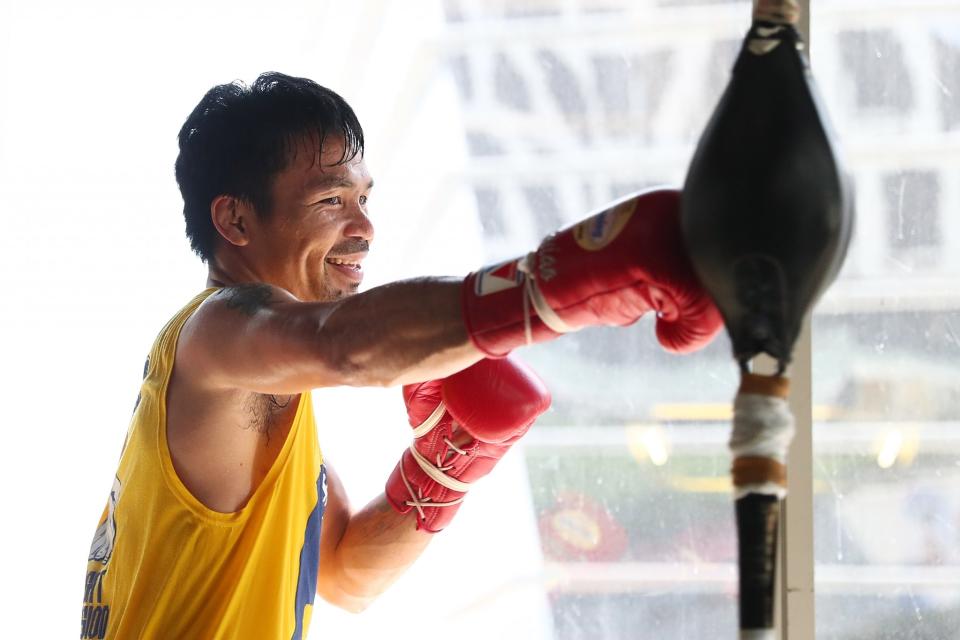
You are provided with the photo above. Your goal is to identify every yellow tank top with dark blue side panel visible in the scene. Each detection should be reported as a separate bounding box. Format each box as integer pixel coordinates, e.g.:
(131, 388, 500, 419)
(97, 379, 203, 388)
(80, 289, 326, 640)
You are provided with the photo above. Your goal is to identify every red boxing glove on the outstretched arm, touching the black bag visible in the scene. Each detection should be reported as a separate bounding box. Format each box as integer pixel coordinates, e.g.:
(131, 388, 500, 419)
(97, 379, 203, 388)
(463, 189, 723, 357)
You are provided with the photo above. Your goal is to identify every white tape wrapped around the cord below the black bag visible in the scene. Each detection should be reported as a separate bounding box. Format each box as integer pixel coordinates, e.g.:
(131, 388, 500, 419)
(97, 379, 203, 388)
(730, 393, 796, 499)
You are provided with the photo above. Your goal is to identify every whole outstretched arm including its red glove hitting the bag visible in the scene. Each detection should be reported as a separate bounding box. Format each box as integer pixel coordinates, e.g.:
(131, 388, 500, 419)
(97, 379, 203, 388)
(177, 190, 722, 394)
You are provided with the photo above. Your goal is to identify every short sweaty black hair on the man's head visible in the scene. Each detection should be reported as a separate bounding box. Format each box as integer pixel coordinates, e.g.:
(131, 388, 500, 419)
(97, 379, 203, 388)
(175, 72, 363, 262)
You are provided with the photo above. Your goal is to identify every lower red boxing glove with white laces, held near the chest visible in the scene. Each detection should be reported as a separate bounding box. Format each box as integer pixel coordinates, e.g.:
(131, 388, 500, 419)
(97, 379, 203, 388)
(386, 358, 550, 533)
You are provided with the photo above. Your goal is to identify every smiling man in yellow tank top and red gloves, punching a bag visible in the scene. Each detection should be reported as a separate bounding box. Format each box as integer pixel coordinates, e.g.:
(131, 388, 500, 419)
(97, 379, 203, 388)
(81, 73, 720, 638)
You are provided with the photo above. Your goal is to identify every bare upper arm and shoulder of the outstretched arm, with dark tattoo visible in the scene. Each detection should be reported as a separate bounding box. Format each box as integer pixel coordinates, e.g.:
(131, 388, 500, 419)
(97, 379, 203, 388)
(176, 283, 346, 394)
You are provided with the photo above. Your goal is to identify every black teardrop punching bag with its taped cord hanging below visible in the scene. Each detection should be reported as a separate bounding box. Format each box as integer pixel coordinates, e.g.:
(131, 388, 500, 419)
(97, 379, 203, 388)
(681, 0, 854, 640)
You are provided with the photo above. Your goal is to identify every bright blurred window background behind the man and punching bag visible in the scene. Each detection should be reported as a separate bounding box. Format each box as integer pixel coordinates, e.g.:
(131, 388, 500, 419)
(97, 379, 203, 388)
(0, 0, 960, 640)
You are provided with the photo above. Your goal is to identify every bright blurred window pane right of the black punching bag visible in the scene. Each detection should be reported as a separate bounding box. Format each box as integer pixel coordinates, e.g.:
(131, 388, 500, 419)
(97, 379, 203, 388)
(813, 0, 960, 640)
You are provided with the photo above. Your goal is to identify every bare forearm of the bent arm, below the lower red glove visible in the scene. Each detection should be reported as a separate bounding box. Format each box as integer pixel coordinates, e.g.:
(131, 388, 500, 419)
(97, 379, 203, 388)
(321, 494, 433, 612)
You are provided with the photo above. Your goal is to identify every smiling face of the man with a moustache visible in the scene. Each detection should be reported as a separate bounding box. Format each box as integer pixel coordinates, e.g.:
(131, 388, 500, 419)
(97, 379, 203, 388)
(249, 137, 373, 301)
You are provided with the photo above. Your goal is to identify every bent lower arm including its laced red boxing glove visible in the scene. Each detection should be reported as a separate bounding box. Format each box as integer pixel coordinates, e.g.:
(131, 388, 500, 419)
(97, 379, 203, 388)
(319, 357, 550, 611)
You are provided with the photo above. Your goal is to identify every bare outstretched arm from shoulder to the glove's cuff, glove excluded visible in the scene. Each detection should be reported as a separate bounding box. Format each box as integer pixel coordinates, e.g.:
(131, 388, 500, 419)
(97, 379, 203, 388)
(177, 278, 482, 394)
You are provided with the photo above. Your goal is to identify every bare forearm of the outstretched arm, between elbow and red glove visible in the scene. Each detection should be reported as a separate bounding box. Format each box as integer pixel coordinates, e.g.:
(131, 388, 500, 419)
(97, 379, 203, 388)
(319, 278, 483, 386)
